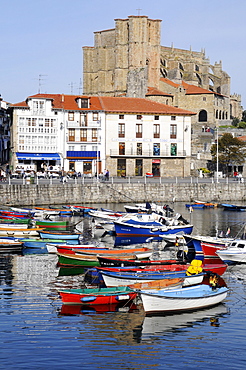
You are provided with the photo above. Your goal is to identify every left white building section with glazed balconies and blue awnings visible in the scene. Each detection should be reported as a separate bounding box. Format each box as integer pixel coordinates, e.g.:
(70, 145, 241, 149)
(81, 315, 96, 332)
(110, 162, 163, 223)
(11, 94, 104, 174)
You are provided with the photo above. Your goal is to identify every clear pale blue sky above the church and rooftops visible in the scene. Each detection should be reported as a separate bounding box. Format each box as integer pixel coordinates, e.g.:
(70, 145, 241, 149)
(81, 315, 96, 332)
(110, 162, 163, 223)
(0, 0, 246, 109)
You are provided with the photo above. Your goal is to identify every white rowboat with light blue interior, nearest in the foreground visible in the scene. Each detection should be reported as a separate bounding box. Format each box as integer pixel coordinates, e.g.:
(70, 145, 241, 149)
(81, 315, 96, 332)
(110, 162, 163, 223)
(139, 284, 228, 313)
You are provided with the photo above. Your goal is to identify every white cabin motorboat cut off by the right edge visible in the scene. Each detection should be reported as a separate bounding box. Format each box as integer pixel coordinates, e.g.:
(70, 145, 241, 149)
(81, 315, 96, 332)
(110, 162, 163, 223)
(216, 239, 246, 263)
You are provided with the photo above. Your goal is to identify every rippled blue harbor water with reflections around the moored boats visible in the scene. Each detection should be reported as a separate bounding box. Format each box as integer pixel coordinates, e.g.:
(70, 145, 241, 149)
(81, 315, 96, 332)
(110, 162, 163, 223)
(0, 203, 246, 370)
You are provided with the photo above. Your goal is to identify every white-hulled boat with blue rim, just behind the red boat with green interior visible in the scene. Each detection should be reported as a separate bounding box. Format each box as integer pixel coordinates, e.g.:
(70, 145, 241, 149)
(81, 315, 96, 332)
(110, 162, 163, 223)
(101, 271, 204, 287)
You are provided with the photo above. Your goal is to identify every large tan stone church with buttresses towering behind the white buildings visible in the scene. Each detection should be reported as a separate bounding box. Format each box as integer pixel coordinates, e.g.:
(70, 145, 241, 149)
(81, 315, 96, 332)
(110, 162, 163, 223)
(83, 16, 242, 175)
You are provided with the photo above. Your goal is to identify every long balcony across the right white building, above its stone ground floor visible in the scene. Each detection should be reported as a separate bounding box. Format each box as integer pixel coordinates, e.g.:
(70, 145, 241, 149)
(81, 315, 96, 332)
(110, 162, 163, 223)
(110, 149, 186, 158)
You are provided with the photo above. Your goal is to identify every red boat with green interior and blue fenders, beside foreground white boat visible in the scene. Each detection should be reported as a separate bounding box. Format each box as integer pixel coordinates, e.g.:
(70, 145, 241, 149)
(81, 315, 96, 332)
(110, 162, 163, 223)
(59, 286, 137, 305)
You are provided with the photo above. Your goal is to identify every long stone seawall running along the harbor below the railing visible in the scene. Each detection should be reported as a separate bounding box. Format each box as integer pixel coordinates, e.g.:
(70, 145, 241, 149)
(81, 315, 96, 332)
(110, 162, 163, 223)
(0, 182, 246, 206)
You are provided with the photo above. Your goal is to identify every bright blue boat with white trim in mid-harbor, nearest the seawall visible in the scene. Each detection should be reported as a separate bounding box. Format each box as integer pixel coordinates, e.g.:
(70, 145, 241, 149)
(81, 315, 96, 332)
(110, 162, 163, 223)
(114, 221, 193, 240)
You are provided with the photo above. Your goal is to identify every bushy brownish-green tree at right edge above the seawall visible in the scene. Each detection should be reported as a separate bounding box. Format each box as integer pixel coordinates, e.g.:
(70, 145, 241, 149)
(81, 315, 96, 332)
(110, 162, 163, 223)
(211, 133, 246, 173)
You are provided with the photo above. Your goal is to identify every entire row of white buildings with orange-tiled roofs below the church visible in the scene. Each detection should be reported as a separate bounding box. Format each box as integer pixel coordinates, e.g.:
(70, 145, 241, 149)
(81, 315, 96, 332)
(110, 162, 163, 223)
(8, 94, 194, 177)
